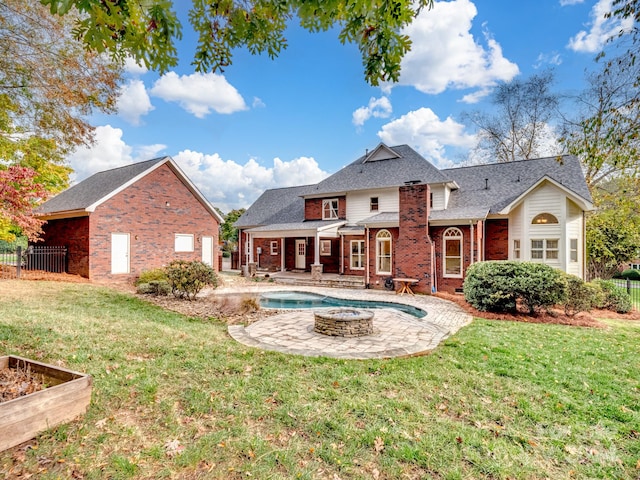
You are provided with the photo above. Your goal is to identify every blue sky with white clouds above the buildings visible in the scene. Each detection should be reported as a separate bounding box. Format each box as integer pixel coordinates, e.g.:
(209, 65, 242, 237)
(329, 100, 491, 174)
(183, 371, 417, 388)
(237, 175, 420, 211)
(69, 0, 624, 213)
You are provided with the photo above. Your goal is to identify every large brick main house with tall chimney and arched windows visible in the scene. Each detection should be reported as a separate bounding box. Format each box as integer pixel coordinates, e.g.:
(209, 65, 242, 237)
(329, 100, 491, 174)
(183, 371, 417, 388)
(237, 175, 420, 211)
(236, 144, 593, 293)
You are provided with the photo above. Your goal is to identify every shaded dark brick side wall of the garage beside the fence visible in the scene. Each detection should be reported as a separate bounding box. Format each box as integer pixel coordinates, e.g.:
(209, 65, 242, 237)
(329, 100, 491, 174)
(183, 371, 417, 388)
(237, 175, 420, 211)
(42, 217, 89, 278)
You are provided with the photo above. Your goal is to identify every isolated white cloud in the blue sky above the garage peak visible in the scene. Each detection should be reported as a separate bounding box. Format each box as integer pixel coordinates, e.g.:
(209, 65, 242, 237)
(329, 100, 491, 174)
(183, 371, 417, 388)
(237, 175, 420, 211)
(151, 72, 247, 118)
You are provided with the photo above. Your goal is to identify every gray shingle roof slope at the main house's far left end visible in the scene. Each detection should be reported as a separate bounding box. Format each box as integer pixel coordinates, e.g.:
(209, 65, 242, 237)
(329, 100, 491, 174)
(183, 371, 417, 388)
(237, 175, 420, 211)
(235, 185, 315, 228)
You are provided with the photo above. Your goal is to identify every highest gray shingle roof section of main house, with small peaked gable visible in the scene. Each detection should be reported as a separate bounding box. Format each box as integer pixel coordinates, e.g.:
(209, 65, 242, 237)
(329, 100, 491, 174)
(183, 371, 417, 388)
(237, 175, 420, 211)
(309, 145, 450, 195)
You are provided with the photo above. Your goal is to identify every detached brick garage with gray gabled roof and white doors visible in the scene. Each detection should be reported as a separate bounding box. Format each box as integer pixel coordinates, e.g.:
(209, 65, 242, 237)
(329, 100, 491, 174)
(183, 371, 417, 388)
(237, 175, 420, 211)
(37, 157, 222, 280)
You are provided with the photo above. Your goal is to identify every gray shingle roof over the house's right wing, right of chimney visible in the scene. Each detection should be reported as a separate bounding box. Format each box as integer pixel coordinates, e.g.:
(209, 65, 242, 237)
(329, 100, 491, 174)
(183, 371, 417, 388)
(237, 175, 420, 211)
(442, 155, 592, 218)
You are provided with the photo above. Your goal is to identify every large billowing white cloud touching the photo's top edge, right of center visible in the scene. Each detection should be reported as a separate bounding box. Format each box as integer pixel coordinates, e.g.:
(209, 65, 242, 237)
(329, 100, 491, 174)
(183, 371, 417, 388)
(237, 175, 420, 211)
(400, 0, 518, 94)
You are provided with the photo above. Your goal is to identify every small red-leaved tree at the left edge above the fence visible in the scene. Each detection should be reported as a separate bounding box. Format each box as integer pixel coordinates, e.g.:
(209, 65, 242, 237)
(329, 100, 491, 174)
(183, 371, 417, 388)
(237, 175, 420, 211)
(0, 165, 46, 242)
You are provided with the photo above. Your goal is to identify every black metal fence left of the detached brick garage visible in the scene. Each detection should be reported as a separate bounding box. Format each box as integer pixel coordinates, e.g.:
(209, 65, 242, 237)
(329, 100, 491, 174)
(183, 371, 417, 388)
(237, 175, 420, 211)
(0, 245, 67, 278)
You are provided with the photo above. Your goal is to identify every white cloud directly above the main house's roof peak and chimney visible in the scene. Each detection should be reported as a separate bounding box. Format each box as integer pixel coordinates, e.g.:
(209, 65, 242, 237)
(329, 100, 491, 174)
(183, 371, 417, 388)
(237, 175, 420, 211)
(378, 108, 476, 167)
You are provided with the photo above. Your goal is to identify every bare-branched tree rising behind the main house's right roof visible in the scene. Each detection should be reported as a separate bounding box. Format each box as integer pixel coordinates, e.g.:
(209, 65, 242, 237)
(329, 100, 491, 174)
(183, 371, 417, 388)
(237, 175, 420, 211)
(463, 71, 559, 162)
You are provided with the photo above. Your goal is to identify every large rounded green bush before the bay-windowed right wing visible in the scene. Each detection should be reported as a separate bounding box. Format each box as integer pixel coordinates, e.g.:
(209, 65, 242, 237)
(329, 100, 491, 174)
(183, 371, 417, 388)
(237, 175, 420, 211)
(463, 261, 567, 313)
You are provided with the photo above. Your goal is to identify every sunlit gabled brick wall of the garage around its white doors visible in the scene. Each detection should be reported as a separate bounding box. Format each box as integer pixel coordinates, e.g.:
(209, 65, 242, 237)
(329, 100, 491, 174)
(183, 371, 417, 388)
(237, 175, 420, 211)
(89, 164, 219, 279)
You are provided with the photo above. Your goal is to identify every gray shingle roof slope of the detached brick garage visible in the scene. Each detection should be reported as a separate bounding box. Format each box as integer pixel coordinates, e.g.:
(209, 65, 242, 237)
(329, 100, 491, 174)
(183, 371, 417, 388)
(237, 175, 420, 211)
(36, 157, 170, 215)
